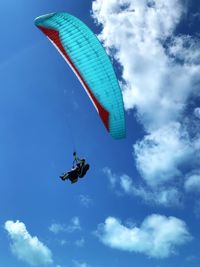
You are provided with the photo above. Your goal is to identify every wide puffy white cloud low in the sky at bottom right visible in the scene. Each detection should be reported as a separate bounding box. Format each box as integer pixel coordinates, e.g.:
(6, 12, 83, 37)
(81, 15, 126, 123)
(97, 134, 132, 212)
(96, 214, 192, 258)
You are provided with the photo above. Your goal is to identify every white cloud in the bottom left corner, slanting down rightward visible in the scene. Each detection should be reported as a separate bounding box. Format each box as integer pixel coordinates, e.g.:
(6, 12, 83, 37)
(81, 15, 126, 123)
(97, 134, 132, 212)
(4, 221, 53, 266)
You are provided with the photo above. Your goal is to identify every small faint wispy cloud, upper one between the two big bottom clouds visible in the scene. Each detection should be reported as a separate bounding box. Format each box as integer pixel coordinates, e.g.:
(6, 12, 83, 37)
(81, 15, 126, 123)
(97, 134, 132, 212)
(49, 216, 81, 234)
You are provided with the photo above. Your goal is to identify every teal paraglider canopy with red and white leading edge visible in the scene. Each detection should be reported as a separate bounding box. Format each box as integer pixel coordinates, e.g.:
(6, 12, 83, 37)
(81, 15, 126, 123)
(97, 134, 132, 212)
(35, 13, 125, 139)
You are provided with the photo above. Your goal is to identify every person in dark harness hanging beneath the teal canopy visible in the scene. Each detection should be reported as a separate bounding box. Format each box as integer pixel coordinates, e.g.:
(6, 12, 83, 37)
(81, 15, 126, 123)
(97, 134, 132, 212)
(60, 152, 90, 183)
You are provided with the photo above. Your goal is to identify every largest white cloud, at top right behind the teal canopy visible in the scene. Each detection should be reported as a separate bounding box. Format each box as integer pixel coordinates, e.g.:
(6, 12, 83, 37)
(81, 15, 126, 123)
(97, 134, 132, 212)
(93, 0, 200, 129)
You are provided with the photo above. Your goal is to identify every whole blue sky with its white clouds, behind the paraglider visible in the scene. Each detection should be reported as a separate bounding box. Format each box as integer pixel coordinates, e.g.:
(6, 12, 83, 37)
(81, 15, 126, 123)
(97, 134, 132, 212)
(0, 0, 200, 267)
